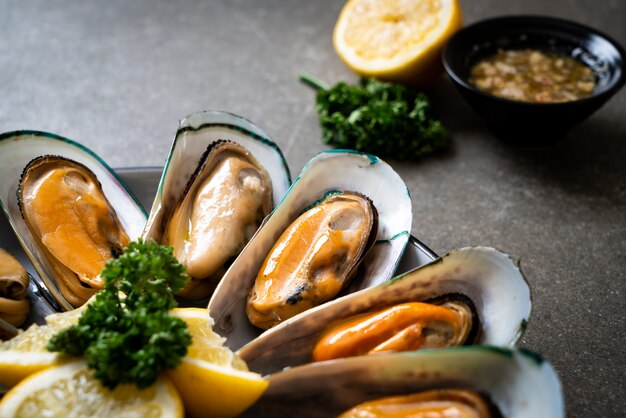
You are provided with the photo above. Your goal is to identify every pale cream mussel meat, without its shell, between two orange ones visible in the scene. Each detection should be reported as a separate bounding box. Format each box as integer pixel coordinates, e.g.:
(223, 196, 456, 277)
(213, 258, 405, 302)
(161, 141, 273, 299)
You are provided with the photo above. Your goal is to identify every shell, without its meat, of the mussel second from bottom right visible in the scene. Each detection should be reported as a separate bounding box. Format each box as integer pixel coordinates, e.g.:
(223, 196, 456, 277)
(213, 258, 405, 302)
(239, 247, 531, 374)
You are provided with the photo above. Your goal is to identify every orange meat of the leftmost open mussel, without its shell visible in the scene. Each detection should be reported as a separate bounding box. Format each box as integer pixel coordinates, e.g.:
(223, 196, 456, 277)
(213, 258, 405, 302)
(18, 155, 130, 307)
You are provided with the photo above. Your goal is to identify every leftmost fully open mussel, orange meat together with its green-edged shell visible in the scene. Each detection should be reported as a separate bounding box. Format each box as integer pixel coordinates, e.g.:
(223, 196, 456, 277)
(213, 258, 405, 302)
(0, 131, 146, 310)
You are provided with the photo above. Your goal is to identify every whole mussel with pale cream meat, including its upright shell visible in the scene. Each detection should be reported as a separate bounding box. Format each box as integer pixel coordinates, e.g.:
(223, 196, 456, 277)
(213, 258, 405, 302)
(143, 112, 290, 300)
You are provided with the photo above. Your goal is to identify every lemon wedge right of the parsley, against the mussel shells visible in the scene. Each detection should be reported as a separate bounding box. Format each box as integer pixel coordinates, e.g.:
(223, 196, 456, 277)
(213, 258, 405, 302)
(167, 308, 268, 418)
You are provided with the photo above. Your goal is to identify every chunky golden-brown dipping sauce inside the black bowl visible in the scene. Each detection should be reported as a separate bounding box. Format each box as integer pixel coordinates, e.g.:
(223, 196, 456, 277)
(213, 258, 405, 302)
(469, 49, 596, 103)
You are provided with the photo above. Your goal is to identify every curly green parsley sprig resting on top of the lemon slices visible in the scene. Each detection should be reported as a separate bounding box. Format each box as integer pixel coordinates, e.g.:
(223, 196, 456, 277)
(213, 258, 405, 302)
(47, 239, 191, 389)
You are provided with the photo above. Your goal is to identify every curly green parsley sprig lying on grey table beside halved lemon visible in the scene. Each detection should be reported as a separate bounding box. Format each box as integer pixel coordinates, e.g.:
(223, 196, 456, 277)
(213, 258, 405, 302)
(300, 74, 448, 160)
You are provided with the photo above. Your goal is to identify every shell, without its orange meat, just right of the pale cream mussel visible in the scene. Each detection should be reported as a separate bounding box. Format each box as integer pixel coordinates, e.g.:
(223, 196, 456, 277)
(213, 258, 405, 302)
(209, 150, 412, 349)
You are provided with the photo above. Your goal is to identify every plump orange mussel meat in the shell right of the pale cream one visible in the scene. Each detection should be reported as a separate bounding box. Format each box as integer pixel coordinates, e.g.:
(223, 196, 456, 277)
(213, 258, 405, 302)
(246, 192, 378, 329)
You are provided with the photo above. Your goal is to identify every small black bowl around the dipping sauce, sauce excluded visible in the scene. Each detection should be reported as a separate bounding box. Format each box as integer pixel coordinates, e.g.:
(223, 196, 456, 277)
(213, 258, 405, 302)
(443, 16, 626, 145)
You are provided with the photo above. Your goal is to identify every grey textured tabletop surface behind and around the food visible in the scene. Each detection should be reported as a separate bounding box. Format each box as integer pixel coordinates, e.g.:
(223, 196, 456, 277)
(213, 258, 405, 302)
(0, 0, 626, 417)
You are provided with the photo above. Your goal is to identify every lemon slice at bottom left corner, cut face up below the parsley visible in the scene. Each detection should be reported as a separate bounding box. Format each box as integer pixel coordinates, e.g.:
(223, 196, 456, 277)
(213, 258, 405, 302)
(0, 361, 183, 418)
